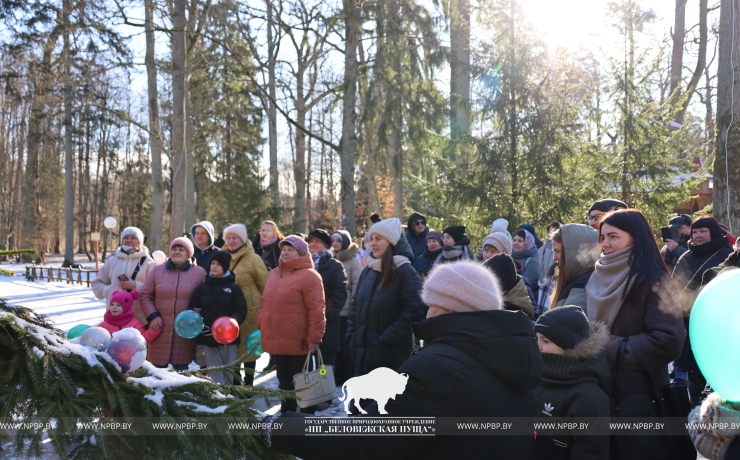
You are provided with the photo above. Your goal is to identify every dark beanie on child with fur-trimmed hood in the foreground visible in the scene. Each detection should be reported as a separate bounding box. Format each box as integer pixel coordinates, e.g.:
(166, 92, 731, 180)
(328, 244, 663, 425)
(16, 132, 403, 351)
(534, 305, 590, 350)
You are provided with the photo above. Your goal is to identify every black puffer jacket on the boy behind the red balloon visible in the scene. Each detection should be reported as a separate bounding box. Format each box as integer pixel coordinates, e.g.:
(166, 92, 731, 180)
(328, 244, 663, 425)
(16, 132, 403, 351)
(188, 272, 249, 347)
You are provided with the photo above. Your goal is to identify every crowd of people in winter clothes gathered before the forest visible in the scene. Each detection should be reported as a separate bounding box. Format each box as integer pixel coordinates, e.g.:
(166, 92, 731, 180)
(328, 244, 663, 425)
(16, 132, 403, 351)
(92, 199, 740, 460)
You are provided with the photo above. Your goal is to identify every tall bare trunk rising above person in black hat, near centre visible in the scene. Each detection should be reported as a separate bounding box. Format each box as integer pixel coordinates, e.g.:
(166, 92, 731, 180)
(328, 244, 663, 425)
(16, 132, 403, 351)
(339, 0, 359, 237)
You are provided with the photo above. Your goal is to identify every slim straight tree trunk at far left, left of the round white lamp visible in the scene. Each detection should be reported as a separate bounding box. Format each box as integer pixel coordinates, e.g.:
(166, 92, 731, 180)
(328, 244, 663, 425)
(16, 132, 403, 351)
(62, 0, 75, 265)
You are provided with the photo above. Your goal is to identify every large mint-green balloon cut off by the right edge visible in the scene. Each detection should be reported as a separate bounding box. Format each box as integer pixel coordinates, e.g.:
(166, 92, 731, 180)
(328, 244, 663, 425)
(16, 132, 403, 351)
(689, 270, 740, 402)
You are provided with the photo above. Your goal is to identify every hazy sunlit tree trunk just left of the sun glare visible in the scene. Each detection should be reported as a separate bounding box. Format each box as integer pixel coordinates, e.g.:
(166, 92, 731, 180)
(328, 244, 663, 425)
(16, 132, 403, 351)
(450, 0, 470, 164)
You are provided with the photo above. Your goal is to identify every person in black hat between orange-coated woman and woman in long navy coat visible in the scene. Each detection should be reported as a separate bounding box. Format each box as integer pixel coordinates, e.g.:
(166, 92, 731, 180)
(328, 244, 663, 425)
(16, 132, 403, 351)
(308, 228, 347, 366)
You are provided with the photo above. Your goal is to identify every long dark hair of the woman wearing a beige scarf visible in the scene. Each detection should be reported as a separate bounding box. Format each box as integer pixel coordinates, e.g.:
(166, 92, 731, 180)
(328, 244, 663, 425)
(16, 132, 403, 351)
(599, 209, 670, 295)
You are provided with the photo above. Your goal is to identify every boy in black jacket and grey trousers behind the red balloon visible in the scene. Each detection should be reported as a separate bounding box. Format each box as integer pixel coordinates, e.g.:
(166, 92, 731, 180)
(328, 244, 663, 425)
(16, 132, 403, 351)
(188, 251, 247, 385)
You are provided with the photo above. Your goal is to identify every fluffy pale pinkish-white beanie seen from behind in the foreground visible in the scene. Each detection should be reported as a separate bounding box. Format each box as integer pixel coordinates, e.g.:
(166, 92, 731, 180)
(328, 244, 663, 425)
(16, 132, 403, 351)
(422, 260, 502, 312)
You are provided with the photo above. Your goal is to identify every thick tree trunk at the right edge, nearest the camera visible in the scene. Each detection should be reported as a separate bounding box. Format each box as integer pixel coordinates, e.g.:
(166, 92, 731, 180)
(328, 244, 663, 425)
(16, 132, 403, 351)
(713, 0, 740, 234)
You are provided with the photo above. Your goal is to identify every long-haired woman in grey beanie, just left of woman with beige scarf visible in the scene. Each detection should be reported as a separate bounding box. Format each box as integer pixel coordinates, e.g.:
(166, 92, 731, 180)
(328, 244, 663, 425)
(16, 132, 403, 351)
(550, 224, 599, 314)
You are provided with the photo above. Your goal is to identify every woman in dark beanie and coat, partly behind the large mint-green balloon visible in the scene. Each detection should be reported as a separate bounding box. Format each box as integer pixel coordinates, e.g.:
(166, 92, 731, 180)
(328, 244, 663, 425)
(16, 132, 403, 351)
(673, 216, 732, 403)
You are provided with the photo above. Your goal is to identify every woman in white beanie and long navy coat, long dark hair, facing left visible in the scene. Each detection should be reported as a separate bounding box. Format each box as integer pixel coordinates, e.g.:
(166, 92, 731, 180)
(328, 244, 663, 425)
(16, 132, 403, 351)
(347, 217, 427, 376)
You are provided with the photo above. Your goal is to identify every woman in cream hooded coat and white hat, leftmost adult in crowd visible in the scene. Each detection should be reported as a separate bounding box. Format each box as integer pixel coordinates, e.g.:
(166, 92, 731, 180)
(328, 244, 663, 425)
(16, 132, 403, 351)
(90, 227, 157, 325)
